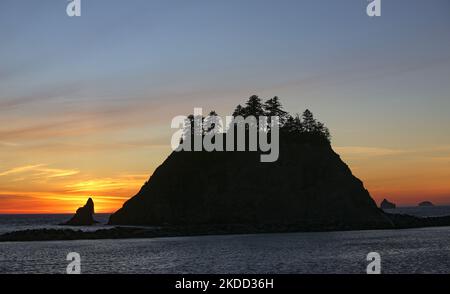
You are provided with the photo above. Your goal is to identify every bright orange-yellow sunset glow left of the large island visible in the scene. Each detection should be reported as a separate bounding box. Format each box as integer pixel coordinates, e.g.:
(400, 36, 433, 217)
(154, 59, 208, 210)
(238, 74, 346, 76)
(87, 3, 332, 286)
(0, 168, 151, 214)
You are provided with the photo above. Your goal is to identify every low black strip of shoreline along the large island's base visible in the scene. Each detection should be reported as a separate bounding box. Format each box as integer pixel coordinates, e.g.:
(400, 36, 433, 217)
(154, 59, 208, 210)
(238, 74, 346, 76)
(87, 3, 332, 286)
(0, 214, 450, 242)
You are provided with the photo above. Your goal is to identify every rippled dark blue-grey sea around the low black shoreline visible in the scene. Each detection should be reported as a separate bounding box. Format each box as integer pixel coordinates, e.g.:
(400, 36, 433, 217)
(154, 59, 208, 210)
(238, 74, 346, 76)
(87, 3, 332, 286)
(0, 207, 450, 274)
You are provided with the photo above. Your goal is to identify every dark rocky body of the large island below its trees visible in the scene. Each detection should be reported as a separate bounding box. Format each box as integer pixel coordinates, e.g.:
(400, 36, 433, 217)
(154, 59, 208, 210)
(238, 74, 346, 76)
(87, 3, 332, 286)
(109, 140, 392, 230)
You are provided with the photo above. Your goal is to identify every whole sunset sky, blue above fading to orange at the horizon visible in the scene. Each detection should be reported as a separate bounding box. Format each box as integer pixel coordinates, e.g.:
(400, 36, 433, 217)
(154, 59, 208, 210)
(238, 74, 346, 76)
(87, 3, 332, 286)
(0, 0, 450, 213)
